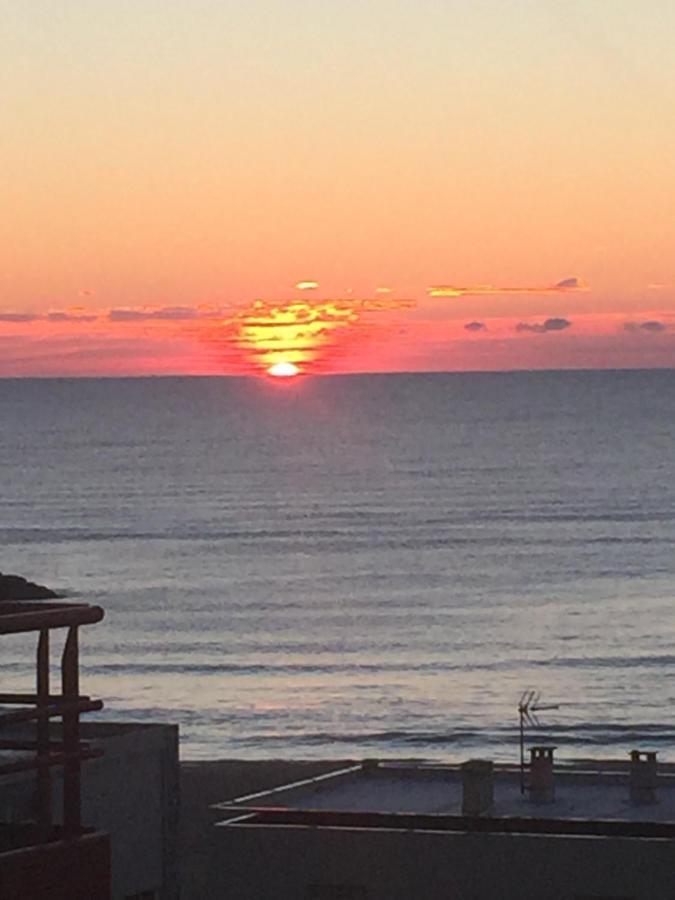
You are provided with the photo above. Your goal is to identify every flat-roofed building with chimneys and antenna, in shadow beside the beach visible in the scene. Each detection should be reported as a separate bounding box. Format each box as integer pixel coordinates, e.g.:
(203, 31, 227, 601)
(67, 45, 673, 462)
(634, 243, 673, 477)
(211, 747, 675, 900)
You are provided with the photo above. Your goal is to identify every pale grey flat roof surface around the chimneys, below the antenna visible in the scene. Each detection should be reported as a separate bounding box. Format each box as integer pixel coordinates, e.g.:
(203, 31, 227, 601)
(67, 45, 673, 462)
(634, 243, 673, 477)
(214, 762, 675, 834)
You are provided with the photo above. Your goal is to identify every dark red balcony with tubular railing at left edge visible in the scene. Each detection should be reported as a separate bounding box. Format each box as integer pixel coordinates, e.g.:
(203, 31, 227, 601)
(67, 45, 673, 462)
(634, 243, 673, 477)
(0, 600, 110, 900)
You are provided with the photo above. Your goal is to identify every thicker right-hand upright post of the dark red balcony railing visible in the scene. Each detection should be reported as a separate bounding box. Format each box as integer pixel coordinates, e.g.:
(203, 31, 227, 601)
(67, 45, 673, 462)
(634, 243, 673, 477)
(61, 625, 82, 835)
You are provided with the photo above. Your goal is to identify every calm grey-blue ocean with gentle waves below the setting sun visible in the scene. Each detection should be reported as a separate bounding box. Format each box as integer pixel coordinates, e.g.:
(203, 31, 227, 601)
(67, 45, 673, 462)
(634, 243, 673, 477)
(0, 370, 675, 762)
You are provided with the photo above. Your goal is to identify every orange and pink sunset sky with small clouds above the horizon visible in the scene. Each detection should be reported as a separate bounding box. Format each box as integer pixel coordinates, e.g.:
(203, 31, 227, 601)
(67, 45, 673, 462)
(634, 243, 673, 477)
(0, 0, 675, 376)
